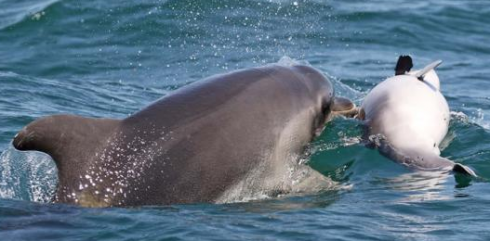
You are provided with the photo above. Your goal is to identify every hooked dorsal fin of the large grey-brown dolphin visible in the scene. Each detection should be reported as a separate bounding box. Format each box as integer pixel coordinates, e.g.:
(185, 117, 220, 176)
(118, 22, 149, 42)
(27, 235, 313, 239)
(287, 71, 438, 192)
(13, 115, 119, 179)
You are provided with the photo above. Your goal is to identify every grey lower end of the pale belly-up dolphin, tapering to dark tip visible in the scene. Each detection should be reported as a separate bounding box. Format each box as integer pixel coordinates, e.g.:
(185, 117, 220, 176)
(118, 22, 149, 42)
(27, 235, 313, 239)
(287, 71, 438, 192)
(369, 136, 477, 177)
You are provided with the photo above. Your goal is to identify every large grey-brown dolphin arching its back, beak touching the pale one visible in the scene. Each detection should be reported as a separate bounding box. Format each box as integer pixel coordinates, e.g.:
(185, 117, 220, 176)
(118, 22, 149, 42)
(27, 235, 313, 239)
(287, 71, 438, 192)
(13, 65, 354, 207)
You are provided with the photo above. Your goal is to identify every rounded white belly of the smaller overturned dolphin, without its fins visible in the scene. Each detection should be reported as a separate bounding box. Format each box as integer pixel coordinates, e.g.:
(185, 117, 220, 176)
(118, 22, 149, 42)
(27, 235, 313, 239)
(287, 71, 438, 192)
(362, 75, 449, 155)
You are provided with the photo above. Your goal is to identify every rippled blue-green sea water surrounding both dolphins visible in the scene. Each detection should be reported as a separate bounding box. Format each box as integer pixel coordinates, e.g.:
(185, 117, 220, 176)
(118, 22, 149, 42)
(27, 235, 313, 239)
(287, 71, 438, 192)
(0, 0, 490, 240)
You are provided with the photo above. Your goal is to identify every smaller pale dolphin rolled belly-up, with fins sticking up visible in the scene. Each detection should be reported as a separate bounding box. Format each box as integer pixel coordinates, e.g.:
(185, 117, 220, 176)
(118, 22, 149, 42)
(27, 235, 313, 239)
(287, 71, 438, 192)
(358, 56, 476, 176)
